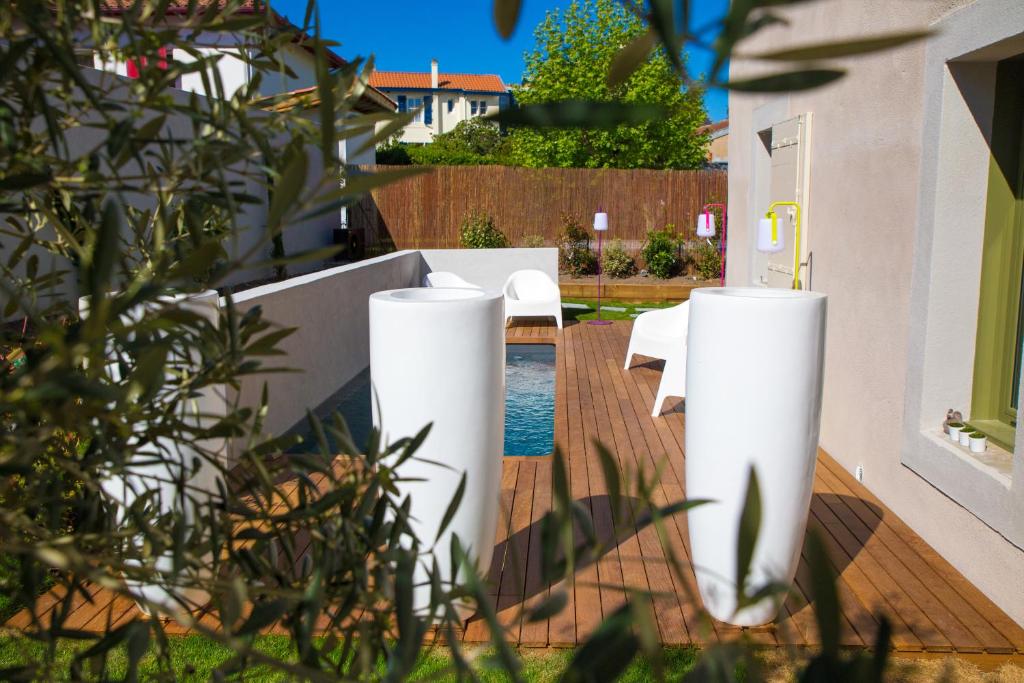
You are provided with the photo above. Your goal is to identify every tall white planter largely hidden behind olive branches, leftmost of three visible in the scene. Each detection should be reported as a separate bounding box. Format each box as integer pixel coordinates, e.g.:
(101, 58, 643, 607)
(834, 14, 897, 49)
(79, 290, 227, 612)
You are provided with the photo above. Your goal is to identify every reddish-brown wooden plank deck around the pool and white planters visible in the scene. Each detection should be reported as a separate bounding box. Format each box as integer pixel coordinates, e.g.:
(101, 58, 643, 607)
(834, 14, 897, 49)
(12, 322, 1024, 660)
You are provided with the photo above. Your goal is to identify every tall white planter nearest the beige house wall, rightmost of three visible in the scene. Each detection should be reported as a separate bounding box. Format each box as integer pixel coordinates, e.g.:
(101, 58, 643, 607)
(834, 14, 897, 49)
(686, 288, 826, 626)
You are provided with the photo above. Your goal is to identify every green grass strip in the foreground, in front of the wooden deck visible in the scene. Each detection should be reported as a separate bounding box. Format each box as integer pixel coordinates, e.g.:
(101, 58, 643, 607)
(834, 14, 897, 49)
(0, 636, 697, 682)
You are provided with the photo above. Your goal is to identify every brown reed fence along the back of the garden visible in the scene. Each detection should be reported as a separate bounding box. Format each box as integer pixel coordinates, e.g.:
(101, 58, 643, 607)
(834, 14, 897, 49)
(349, 166, 727, 253)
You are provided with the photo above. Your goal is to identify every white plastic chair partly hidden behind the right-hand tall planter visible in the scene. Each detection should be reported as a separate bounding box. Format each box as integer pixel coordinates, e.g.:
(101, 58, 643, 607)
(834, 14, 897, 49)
(625, 301, 690, 418)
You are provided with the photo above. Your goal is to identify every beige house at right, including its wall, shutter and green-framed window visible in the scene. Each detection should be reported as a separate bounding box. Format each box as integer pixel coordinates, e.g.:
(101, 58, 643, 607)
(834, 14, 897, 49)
(727, 0, 1024, 624)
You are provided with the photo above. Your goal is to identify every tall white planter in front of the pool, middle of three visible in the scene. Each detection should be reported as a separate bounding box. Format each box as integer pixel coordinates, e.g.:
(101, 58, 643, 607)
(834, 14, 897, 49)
(370, 288, 505, 606)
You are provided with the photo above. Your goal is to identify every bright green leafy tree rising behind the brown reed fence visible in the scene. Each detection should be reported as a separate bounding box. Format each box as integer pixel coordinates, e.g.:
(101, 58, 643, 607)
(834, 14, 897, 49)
(510, 0, 708, 169)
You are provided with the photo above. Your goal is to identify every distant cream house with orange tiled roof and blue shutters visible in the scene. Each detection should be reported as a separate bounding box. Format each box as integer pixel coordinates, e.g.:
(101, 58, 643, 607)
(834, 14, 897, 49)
(370, 59, 512, 144)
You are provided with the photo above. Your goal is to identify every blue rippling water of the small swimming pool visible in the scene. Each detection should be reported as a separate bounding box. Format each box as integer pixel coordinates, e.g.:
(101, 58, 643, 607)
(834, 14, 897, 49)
(289, 344, 555, 456)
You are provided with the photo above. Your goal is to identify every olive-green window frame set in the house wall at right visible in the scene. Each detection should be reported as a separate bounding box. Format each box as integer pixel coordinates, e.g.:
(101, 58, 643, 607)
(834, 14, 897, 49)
(970, 55, 1024, 451)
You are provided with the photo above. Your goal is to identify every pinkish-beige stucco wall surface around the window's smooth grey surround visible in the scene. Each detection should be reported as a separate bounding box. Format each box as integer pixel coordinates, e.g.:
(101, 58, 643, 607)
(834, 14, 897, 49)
(727, 0, 1024, 623)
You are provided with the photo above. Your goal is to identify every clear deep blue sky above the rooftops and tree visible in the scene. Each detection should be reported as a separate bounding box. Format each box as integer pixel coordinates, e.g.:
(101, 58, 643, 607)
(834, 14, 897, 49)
(271, 0, 729, 121)
